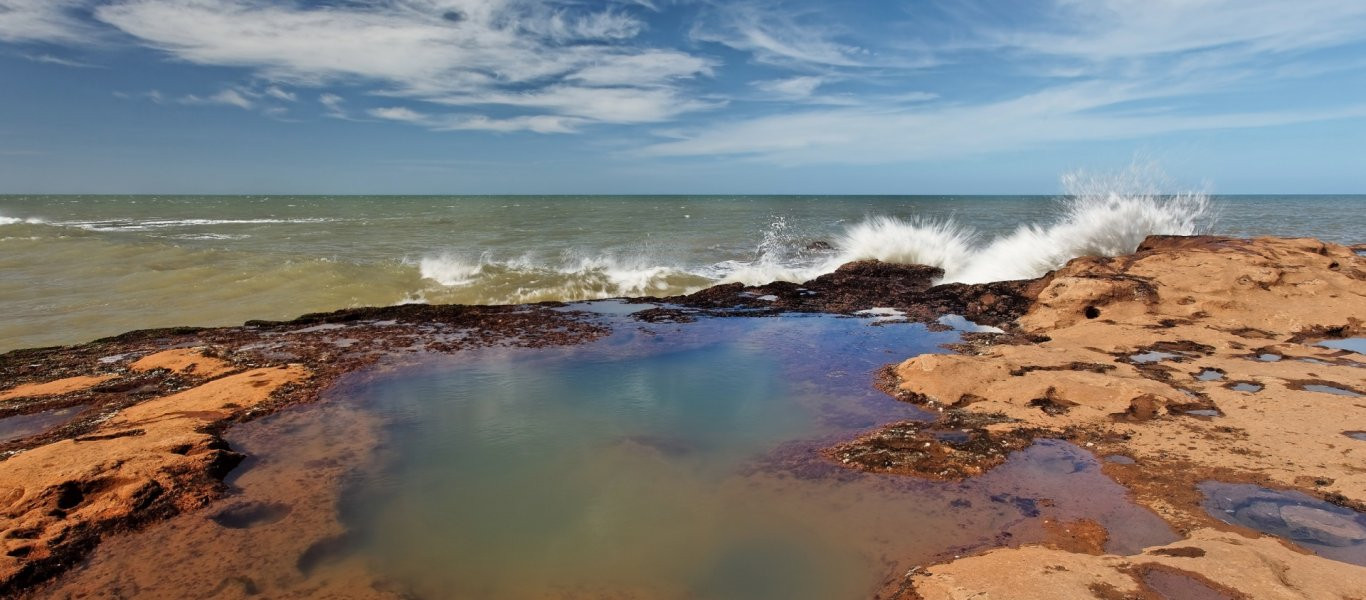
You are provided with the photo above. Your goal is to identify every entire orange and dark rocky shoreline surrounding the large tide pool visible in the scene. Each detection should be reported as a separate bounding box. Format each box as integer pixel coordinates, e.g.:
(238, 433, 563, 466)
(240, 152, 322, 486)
(0, 238, 1366, 600)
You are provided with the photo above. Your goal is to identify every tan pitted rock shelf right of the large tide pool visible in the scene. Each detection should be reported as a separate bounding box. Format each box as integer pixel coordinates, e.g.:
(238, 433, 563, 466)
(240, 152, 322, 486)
(831, 236, 1366, 599)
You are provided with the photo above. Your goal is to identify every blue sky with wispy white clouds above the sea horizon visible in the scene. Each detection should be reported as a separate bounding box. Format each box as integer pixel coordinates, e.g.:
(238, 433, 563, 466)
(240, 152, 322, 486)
(0, 0, 1366, 194)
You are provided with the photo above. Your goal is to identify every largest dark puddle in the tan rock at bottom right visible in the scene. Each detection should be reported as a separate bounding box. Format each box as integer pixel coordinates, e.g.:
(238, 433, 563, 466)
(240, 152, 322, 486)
(1199, 481, 1366, 566)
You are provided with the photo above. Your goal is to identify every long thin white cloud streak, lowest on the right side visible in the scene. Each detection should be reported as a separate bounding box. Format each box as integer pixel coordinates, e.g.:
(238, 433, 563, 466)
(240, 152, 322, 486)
(643, 85, 1366, 165)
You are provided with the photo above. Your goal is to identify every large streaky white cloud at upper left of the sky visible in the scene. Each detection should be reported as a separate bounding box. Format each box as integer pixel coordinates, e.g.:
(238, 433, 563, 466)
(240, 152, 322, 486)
(94, 0, 713, 130)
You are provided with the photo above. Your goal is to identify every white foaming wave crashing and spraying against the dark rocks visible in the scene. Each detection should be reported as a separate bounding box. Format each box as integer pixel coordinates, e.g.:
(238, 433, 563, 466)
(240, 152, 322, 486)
(418, 167, 1216, 302)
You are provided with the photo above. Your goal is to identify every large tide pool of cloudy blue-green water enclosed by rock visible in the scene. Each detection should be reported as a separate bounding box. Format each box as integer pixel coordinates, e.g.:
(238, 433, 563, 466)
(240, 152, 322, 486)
(346, 316, 1171, 600)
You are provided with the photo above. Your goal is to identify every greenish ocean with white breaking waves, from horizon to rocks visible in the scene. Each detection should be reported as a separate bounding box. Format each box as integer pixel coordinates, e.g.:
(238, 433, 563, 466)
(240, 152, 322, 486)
(0, 188, 1366, 350)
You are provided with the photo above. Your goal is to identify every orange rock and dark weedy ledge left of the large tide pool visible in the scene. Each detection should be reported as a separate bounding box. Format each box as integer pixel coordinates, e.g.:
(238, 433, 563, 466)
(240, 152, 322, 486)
(0, 305, 605, 599)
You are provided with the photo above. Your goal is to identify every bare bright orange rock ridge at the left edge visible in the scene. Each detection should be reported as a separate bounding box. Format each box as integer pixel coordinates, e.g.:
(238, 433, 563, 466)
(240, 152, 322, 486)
(0, 357, 309, 595)
